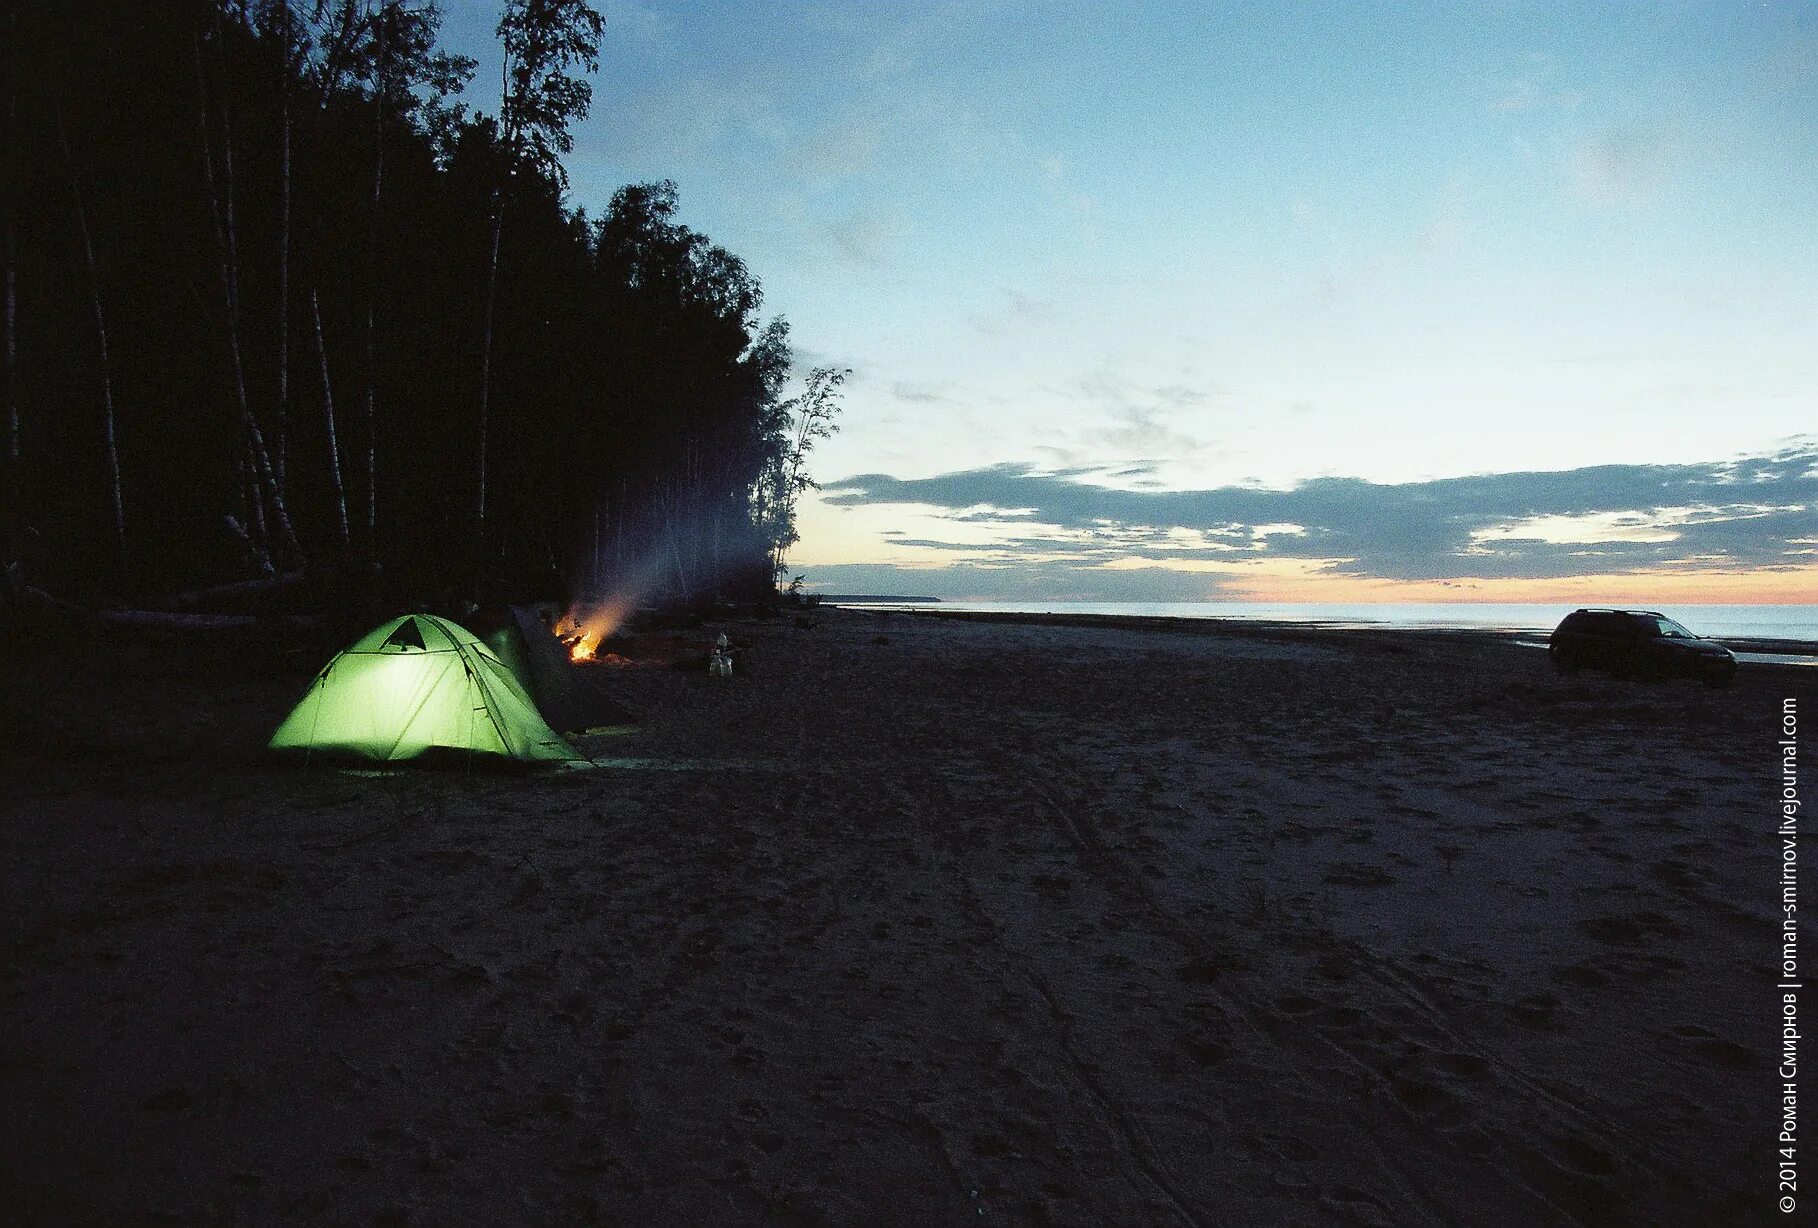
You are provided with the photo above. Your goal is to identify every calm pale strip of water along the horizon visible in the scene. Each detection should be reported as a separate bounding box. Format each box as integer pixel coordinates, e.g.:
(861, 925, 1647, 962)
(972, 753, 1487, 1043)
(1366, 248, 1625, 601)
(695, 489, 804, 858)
(832, 600, 1818, 646)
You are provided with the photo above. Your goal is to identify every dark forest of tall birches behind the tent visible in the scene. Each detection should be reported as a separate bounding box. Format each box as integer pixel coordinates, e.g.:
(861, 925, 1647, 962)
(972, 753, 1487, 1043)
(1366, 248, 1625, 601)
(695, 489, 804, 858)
(4, 0, 842, 604)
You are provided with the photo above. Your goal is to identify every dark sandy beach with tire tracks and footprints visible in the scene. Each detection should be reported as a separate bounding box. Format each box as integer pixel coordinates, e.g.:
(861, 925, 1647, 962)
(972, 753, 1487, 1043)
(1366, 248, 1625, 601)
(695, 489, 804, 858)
(0, 609, 1818, 1226)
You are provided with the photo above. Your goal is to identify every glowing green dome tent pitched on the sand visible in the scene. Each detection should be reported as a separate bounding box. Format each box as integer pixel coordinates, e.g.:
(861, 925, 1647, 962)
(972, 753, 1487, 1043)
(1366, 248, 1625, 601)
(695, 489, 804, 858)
(271, 615, 582, 762)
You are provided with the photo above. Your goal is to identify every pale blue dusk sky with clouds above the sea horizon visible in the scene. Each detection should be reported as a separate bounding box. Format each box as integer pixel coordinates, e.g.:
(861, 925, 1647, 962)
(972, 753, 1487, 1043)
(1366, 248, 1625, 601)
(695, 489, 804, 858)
(444, 0, 1818, 604)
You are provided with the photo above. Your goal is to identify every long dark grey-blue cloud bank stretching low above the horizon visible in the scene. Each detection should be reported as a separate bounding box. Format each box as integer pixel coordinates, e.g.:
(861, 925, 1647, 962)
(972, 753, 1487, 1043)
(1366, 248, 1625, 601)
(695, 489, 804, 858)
(824, 440, 1818, 580)
